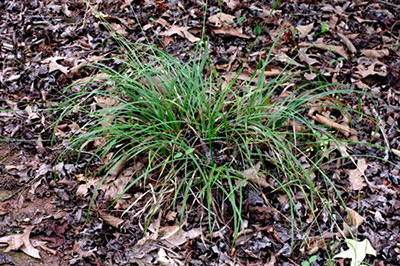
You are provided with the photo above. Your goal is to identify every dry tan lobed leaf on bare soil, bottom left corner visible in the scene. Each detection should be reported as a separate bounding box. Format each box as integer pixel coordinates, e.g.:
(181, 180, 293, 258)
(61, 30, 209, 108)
(0, 226, 40, 259)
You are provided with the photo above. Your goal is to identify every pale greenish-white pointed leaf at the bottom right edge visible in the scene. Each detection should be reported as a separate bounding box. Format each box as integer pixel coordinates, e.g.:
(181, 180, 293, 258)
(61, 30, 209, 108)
(333, 239, 376, 266)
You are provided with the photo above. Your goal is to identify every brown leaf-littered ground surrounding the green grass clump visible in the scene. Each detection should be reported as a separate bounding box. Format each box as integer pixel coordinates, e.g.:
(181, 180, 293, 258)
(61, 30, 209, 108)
(0, 0, 400, 265)
